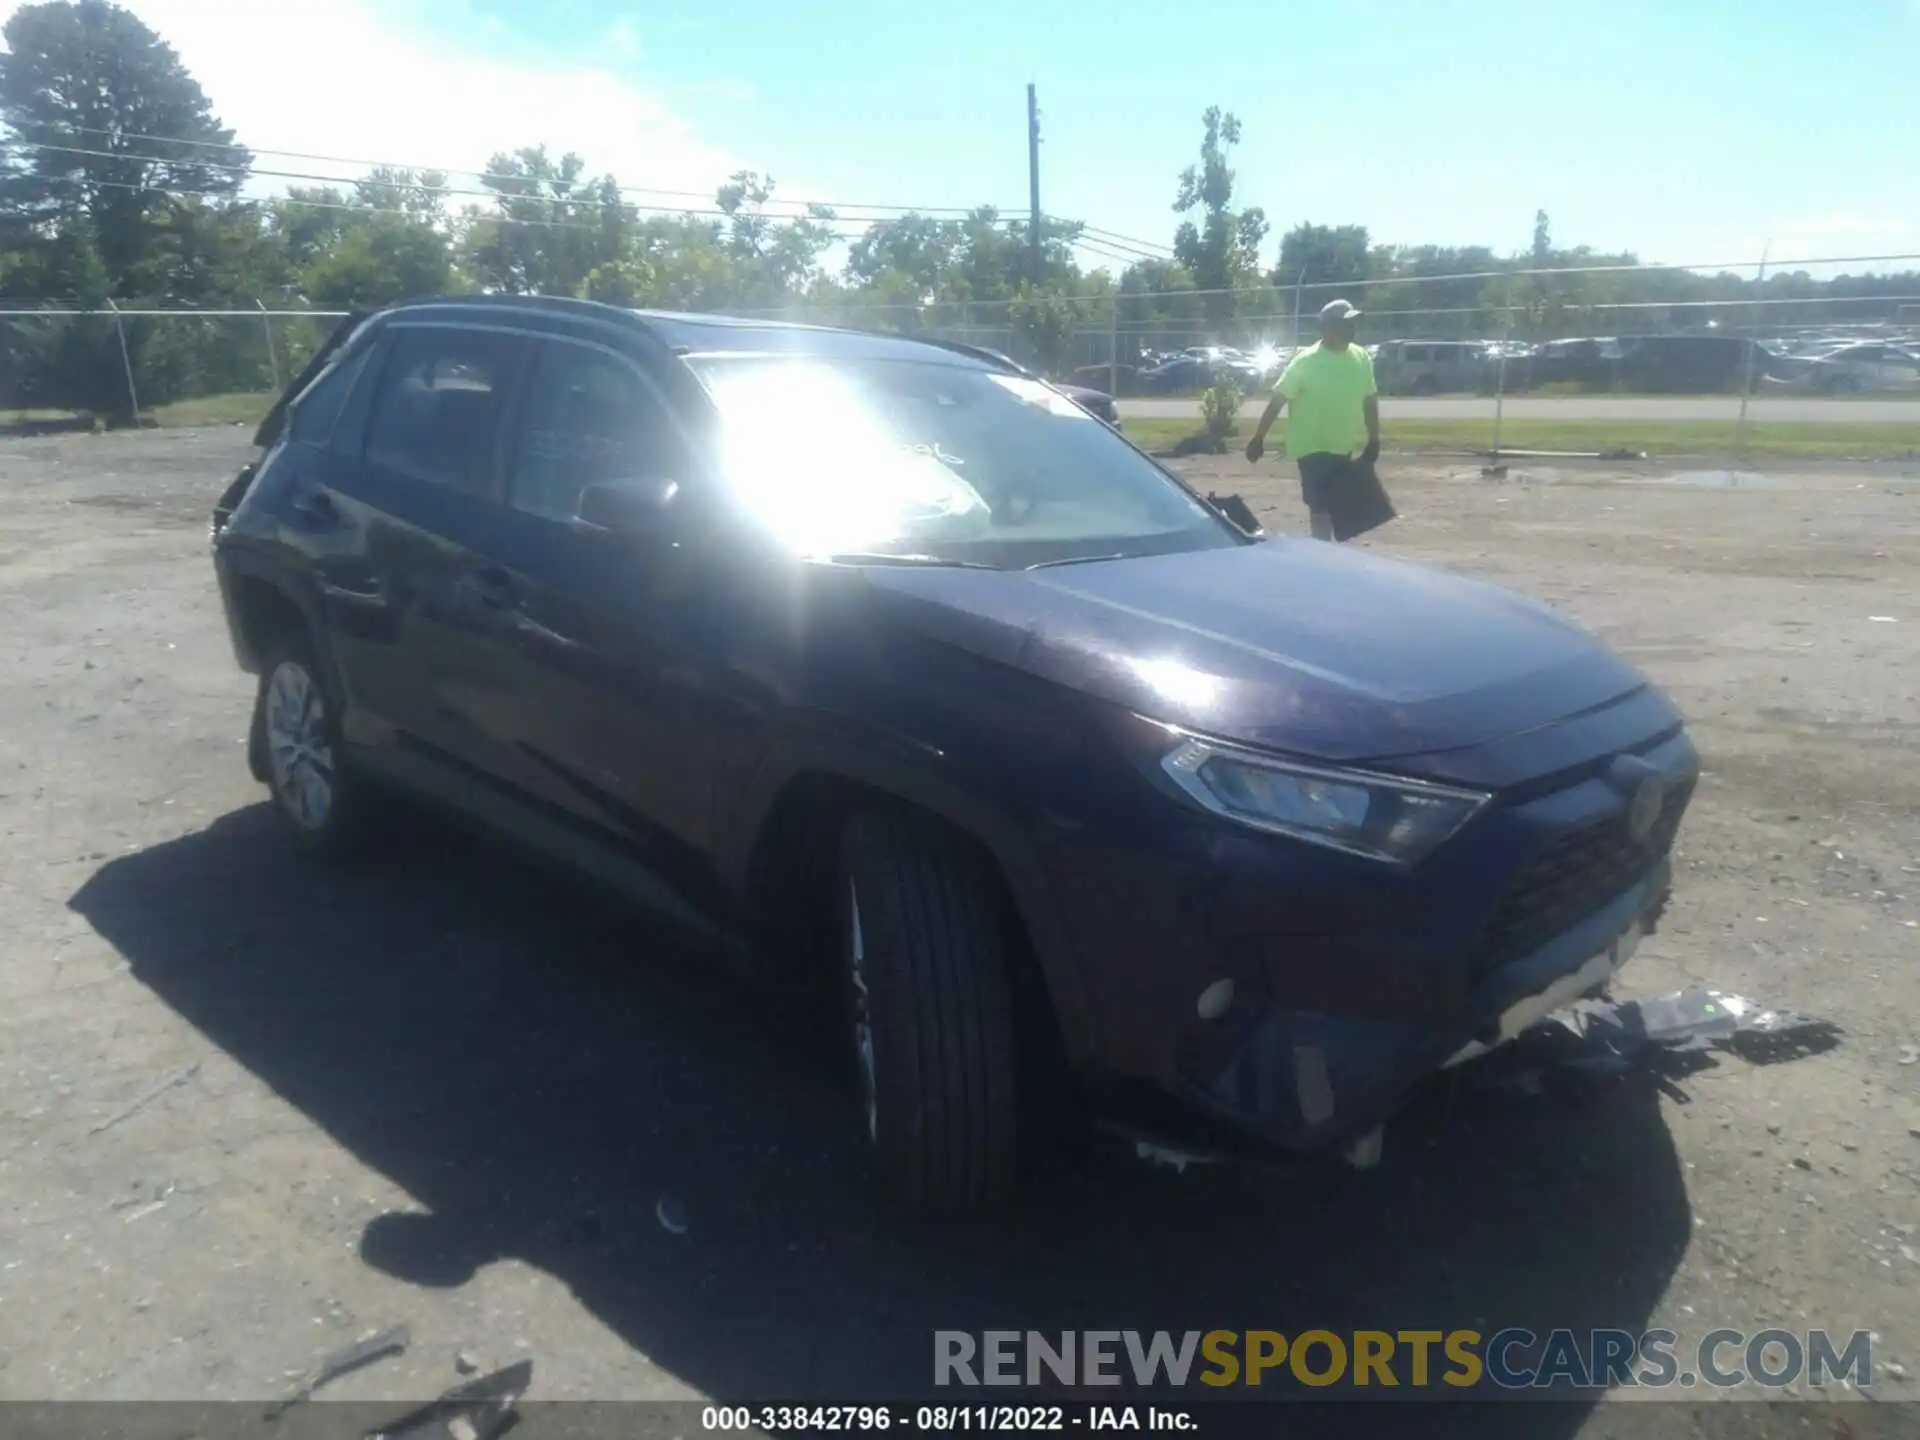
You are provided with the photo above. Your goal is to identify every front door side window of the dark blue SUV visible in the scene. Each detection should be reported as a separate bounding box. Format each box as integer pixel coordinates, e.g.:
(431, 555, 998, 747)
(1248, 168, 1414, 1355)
(507, 340, 684, 520)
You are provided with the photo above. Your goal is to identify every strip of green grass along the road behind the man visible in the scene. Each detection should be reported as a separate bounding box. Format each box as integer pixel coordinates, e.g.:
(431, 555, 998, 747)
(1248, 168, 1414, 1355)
(1121, 417, 1920, 459)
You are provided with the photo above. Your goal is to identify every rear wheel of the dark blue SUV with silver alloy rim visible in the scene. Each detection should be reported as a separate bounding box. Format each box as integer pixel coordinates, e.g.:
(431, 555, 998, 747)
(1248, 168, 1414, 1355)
(248, 630, 371, 858)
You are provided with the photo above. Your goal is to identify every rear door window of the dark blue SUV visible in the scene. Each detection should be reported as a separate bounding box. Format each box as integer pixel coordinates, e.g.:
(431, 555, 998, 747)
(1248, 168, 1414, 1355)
(367, 326, 516, 495)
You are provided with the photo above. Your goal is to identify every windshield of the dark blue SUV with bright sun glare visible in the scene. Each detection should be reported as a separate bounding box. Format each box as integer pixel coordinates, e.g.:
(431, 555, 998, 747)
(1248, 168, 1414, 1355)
(687, 355, 1240, 568)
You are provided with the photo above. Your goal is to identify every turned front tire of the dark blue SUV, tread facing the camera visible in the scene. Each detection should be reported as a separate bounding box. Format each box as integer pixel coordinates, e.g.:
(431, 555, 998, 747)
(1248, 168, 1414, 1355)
(839, 812, 1020, 1212)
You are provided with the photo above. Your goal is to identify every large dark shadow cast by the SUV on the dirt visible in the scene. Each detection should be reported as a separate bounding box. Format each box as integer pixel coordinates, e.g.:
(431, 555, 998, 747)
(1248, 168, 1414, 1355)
(71, 806, 1692, 1436)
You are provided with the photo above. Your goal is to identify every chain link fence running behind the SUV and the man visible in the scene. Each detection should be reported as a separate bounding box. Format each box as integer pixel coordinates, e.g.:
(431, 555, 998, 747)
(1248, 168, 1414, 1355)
(0, 255, 1920, 449)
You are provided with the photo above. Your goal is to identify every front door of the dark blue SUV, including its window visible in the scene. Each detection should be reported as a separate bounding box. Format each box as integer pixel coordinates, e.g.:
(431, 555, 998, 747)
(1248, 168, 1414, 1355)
(456, 338, 762, 885)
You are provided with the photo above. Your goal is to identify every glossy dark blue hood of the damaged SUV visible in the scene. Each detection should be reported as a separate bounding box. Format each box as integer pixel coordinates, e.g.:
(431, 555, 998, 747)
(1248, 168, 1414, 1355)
(862, 540, 1647, 760)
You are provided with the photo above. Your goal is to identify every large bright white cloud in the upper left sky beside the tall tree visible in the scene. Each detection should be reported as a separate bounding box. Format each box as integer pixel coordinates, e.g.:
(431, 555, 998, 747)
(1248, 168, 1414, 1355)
(0, 0, 756, 204)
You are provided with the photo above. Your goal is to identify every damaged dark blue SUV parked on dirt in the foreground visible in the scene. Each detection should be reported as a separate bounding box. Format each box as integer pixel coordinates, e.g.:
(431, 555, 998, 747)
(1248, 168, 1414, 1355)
(213, 296, 1699, 1208)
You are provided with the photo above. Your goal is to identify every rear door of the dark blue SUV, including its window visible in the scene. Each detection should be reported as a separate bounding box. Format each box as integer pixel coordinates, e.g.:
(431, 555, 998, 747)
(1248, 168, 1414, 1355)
(320, 319, 528, 766)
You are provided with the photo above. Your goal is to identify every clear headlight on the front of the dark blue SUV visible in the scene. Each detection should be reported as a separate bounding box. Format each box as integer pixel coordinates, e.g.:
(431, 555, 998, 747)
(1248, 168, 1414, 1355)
(1162, 739, 1490, 866)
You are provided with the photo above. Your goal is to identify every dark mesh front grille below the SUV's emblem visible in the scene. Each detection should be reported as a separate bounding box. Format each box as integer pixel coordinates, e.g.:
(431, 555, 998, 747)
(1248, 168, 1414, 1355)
(1480, 780, 1693, 968)
